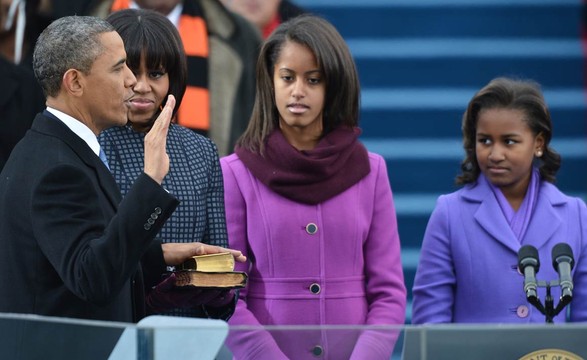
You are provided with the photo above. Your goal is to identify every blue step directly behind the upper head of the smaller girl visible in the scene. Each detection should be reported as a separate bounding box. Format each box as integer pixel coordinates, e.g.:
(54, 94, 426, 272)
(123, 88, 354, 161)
(360, 87, 587, 142)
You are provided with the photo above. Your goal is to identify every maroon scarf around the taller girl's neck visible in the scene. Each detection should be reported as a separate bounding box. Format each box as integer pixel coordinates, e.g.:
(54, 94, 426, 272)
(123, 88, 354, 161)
(235, 127, 370, 205)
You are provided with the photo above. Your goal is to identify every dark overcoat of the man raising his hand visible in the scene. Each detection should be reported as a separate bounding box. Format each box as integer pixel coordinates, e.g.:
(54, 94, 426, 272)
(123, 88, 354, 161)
(0, 112, 178, 322)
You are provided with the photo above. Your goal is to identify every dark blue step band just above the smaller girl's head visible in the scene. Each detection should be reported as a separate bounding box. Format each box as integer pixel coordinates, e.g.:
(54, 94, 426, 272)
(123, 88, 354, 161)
(356, 51, 585, 88)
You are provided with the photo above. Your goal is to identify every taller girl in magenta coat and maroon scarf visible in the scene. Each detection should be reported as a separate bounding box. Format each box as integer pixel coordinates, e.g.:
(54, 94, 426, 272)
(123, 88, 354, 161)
(221, 15, 406, 360)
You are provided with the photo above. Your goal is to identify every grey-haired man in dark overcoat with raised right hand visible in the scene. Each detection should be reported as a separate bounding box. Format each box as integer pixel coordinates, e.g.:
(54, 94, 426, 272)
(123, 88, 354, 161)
(0, 16, 238, 322)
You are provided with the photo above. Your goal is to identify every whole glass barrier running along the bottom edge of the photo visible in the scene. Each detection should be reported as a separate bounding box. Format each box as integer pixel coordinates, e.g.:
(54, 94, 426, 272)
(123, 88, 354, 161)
(0, 314, 587, 360)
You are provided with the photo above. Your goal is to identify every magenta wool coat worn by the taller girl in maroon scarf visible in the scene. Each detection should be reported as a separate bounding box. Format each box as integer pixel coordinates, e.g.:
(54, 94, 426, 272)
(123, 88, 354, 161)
(221, 154, 406, 359)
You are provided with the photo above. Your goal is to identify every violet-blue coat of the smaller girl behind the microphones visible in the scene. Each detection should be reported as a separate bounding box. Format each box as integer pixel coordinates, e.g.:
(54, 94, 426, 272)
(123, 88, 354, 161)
(412, 176, 587, 324)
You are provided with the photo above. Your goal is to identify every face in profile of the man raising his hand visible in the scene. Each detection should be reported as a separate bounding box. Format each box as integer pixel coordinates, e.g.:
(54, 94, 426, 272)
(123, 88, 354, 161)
(80, 31, 136, 133)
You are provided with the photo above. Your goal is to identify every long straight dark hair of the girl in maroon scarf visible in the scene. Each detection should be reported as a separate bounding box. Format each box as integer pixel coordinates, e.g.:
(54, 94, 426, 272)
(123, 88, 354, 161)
(237, 15, 360, 153)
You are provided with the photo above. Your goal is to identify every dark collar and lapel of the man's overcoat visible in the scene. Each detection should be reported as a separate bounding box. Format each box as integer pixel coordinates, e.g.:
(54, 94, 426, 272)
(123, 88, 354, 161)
(33, 110, 122, 209)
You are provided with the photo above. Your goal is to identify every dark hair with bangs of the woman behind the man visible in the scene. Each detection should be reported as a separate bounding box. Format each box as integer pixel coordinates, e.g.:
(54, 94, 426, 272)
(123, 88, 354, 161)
(106, 9, 187, 117)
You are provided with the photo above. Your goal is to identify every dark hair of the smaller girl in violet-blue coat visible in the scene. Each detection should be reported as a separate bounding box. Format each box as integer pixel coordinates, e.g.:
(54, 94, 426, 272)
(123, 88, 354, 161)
(456, 77, 561, 184)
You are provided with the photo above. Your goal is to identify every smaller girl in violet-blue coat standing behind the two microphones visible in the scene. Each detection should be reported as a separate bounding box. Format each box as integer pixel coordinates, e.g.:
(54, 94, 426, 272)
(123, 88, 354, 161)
(412, 78, 587, 324)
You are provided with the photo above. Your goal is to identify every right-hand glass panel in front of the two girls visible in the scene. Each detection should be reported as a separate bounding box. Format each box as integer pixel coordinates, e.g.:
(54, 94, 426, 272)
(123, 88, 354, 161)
(222, 324, 587, 360)
